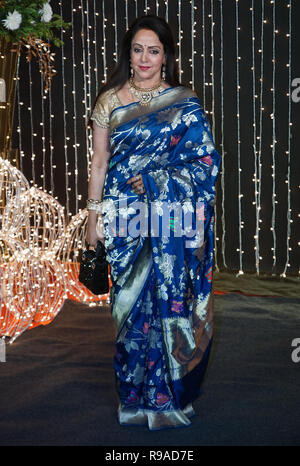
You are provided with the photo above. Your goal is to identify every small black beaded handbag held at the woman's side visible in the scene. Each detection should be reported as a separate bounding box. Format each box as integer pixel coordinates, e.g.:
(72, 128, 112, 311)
(79, 241, 109, 294)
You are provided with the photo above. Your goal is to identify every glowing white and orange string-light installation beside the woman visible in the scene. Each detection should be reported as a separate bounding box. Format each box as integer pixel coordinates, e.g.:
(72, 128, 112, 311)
(0, 159, 109, 343)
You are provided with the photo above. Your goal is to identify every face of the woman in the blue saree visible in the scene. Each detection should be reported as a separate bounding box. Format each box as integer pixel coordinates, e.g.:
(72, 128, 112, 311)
(130, 29, 165, 86)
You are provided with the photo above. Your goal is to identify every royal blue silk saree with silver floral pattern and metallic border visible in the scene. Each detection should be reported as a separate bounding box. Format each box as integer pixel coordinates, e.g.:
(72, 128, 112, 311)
(103, 86, 220, 430)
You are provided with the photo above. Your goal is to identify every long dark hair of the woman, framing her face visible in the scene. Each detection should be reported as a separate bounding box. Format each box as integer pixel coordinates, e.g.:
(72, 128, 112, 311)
(98, 15, 180, 97)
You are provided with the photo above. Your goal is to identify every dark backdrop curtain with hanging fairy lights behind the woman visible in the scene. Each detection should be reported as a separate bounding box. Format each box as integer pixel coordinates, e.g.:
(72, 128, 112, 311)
(13, 0, 300, 276)
